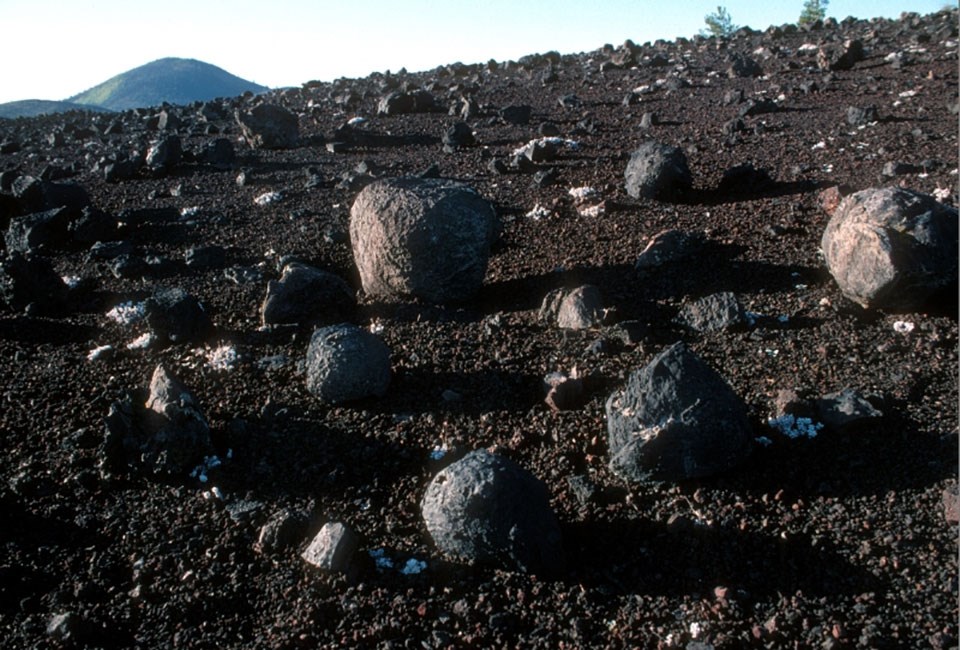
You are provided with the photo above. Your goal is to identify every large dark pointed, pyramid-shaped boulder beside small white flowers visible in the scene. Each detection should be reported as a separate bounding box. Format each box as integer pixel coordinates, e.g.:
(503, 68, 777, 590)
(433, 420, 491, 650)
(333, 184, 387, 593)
(606, 343, 752, 481)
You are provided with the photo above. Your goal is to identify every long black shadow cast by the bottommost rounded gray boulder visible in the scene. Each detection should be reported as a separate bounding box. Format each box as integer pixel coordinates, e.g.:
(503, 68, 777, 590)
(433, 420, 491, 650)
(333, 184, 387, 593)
(563, 518, 881, 599)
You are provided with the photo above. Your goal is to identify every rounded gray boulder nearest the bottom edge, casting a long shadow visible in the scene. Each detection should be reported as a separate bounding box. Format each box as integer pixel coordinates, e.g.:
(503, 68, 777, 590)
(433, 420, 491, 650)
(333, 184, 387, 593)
(421, 449, 565, 575)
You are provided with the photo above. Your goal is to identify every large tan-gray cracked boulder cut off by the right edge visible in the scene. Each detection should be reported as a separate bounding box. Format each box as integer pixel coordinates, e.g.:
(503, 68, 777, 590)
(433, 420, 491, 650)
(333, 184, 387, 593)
(821, 187, 958, 309)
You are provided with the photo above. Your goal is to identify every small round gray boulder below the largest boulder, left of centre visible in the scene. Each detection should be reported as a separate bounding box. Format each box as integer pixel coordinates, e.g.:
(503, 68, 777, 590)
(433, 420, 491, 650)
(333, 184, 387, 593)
(306, 323, 390, 404)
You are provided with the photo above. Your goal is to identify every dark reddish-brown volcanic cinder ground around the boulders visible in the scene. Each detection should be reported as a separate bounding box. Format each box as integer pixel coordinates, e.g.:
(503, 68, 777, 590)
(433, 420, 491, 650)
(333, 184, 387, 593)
(0, 11, 958, 648)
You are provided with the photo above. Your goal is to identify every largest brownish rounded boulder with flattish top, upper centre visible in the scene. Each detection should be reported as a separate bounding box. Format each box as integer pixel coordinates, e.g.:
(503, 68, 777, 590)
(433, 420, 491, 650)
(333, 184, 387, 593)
(350, 178, 499, 303)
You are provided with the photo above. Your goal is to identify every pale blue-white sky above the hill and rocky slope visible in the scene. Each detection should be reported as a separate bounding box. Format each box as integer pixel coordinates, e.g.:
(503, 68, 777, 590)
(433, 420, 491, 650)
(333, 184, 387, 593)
(0, 0, 944, 103)
